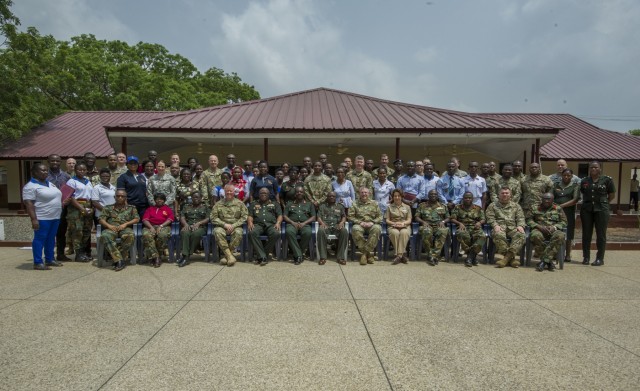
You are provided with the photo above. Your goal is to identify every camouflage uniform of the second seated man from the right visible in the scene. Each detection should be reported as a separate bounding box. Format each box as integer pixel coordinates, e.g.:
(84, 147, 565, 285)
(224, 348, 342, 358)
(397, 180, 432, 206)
(485, 201, 525, 257)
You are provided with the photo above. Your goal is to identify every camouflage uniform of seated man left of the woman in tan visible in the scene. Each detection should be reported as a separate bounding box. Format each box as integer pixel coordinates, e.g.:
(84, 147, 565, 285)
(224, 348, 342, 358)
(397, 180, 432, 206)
(349, 199, 382, 254)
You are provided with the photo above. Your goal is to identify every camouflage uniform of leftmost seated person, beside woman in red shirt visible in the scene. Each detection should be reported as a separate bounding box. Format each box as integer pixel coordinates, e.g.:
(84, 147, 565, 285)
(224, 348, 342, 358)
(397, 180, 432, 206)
(100, 205, 140, 263)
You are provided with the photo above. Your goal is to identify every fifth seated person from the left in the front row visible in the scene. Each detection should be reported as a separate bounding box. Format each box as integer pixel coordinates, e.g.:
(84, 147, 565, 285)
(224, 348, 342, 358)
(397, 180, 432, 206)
(247, 187, 282, 266)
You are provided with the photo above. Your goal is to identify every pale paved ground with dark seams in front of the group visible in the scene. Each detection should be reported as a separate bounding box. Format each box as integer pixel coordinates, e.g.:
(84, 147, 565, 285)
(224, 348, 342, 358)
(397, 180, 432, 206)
(0, 248, 640, 390)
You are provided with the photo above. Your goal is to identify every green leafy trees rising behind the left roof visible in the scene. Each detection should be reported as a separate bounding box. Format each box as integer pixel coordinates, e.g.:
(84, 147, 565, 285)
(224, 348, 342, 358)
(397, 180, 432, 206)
(0, 6, 260, 144)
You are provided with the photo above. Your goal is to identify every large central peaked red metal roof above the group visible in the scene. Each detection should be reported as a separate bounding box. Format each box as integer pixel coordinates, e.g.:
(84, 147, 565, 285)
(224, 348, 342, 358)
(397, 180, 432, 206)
(107, 88, 557, 134)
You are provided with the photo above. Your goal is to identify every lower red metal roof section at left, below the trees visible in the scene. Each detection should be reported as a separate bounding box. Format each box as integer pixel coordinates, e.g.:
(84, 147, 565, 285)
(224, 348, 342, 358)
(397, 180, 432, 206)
(0, 111, 172, 159)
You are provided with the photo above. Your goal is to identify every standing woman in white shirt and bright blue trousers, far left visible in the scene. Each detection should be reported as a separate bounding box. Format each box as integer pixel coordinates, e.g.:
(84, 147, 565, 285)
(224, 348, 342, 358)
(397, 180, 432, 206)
(22, 164, 64, 270)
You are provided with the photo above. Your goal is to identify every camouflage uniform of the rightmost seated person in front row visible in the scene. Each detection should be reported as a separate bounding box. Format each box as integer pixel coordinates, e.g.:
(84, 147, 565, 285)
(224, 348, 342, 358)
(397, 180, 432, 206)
(527, 204, 567, 263)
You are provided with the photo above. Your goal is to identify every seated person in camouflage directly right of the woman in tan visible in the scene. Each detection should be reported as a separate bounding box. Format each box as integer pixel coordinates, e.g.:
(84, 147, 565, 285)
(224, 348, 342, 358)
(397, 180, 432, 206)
(415, 189, 449, 266)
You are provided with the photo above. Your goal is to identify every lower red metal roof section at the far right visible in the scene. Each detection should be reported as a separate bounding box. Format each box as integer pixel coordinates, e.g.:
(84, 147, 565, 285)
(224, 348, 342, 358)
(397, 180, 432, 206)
(482, 113, 640, 162)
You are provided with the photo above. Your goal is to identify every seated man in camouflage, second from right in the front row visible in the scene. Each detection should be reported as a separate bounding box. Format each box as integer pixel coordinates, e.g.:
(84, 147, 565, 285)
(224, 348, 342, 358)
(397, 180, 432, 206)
(485, 186, 525, 268)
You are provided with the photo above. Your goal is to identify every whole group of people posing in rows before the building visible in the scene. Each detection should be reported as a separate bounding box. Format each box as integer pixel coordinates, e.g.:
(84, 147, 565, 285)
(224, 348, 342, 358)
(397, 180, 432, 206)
(23, 151, 615, 271)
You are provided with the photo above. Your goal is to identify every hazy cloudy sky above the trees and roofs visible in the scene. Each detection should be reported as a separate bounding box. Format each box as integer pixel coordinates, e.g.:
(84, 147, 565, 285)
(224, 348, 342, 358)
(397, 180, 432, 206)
(12, 0, 640, 131)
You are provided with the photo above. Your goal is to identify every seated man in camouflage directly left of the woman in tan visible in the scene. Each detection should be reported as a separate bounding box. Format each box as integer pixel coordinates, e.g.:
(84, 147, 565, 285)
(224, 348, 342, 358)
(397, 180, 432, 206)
(349, 186, 382, 265)
